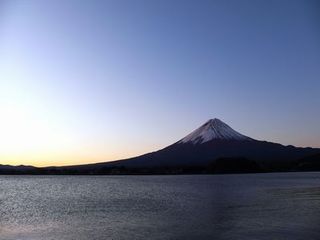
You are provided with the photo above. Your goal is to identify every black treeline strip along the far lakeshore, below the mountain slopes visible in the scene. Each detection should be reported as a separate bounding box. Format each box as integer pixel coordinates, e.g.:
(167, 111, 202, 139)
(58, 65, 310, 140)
(0, 154, 320, 175)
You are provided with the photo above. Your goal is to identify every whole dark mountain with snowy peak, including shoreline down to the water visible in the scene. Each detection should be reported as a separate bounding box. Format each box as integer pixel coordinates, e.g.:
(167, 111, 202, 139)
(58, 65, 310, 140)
(0, 119, 320, 174)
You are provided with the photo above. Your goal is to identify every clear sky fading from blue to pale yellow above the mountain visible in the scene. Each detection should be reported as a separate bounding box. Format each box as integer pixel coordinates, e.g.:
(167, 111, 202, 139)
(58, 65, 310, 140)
(0, 0, 320, 166)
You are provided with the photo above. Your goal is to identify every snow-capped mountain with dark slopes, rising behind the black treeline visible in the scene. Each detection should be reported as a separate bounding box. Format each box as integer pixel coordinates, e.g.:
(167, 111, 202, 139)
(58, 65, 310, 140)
(59, 118, 320, 173)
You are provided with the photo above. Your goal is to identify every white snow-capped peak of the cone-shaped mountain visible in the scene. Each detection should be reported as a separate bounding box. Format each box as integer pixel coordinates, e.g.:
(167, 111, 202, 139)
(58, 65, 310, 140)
(178, 118, 252, 144)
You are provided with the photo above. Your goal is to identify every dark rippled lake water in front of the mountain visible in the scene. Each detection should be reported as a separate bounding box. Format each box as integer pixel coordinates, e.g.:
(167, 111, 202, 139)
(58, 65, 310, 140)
(0, 173, 320, 240)
